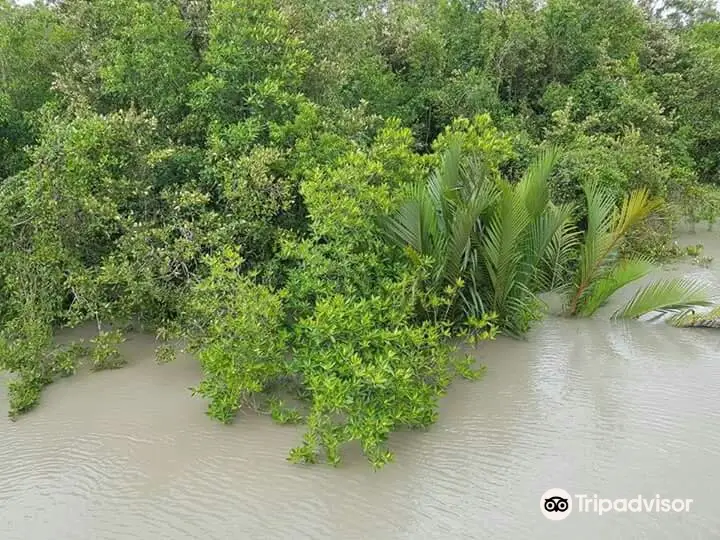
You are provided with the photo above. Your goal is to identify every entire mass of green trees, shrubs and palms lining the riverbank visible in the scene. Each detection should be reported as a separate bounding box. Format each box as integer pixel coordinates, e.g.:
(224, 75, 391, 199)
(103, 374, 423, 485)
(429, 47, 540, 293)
(0, 0, 720, 468)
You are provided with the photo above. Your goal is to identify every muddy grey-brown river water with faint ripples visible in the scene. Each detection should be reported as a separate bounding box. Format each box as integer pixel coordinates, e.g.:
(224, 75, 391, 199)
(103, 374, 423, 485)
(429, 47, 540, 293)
(0, 230, 720, 540)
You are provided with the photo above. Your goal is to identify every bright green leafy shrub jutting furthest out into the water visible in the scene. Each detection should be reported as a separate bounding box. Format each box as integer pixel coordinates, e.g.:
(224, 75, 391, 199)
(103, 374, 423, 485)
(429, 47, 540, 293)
(291, 282, 451, 468)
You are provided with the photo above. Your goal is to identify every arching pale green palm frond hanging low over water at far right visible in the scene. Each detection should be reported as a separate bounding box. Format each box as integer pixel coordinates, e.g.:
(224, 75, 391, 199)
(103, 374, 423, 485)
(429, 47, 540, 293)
(613, 278, 711, 319)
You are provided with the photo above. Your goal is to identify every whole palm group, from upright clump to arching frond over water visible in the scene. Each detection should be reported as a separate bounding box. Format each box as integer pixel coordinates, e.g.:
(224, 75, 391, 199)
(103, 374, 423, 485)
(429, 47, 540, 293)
(385, 141, 709, 335)
